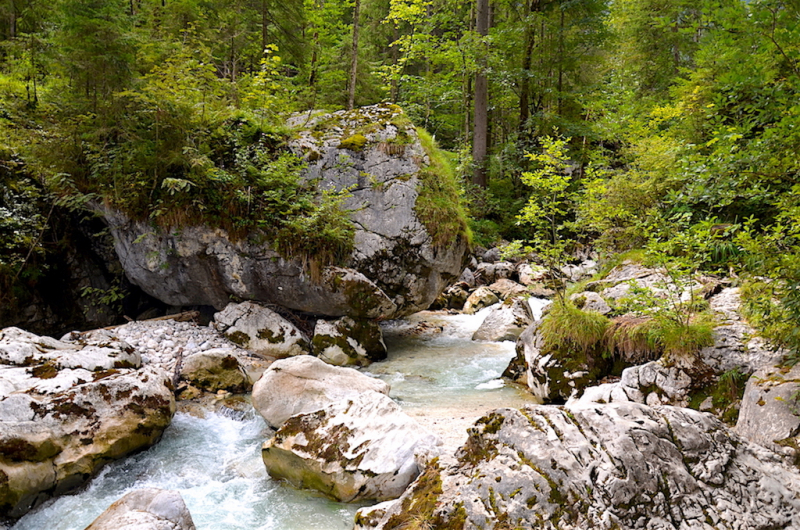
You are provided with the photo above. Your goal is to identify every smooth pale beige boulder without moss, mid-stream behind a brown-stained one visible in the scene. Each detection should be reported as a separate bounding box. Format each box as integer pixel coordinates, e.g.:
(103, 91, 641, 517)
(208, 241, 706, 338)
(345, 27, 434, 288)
(253, 355, 389, 428)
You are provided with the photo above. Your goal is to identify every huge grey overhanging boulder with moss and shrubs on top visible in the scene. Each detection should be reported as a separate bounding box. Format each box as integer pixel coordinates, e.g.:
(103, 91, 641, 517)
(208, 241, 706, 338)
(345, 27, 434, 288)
(97, 105, 468, 318)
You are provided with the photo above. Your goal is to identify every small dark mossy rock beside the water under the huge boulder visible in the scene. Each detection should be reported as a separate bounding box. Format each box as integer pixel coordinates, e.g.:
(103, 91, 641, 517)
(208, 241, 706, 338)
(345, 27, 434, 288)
(311, 317, 386, 366)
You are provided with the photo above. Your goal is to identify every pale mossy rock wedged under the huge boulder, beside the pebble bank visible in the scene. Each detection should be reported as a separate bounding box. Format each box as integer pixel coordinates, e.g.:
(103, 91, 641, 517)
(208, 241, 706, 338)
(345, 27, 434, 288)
(214, 302, 311, 358)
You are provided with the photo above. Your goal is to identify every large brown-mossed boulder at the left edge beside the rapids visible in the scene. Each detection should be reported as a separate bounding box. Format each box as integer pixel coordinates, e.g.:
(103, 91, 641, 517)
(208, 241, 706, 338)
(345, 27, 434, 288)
(0, 328, 175, 517)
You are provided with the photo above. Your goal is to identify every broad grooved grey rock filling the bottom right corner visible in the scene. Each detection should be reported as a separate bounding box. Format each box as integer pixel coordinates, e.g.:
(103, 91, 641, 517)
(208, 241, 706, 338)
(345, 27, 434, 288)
(356, 403, 800, 530)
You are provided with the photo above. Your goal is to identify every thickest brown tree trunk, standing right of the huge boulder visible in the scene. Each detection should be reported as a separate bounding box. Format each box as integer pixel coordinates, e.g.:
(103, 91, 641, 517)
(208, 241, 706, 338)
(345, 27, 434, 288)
(472, 0, 489, 188)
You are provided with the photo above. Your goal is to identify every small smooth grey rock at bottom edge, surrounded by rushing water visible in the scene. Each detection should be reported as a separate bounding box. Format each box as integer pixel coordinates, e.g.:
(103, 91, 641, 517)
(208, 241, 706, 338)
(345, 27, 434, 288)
(86, 488, 195, 530)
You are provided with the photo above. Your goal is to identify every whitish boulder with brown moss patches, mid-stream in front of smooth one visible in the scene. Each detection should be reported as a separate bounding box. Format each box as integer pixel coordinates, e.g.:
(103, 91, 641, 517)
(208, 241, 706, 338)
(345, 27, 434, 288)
(262, 392, 441, 502)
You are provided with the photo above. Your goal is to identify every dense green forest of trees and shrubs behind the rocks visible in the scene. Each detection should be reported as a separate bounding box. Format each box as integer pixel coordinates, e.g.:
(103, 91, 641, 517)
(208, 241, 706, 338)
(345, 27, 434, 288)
(0, 0, 800, 361)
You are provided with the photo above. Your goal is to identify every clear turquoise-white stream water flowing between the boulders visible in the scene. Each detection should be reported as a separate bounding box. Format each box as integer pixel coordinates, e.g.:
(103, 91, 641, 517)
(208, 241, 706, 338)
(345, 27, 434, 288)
(12, 300, 544, 530)
